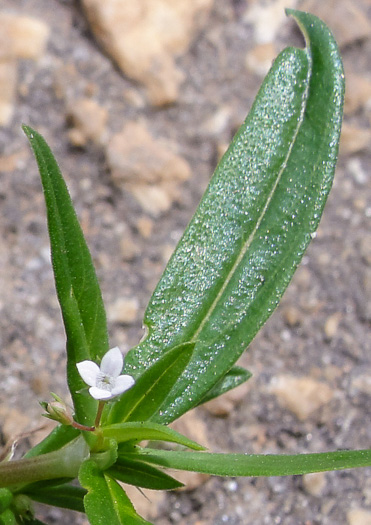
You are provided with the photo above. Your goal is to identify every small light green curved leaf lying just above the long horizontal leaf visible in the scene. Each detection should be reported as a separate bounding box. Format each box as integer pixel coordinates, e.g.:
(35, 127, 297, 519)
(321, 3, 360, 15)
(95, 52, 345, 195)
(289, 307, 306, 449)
(102, 422, 204, 450)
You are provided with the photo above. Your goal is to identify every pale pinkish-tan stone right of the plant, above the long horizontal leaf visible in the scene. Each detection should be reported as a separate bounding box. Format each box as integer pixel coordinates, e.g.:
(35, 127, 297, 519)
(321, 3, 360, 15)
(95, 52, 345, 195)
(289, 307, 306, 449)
(269, 375, 334, 421)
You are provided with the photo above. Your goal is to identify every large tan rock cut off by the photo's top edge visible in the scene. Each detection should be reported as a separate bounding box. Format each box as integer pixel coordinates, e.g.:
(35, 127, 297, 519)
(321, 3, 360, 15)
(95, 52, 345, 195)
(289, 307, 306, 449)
(83, 0, 213, 106)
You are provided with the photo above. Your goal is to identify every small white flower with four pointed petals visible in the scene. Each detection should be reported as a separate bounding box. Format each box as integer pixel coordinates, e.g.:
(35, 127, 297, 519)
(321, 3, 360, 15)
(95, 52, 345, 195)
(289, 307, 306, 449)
(76, 346, 135, 400)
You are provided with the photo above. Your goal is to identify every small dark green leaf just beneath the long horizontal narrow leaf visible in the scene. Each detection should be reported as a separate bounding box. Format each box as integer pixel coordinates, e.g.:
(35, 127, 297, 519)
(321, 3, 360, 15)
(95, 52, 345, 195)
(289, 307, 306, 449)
(107, 457, 184, 490)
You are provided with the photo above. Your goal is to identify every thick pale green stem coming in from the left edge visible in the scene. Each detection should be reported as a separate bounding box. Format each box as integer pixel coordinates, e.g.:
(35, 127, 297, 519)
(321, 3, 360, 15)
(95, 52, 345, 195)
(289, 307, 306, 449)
(0, 436, 89, 488)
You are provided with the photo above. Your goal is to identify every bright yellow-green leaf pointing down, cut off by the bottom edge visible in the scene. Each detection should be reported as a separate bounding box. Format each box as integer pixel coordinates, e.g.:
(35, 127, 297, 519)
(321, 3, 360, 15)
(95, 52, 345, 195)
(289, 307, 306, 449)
(79, 460, 151, 525)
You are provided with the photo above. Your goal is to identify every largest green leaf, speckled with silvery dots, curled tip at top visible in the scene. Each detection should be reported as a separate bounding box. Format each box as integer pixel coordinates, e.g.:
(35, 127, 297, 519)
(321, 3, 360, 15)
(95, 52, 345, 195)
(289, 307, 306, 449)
(126, 11, 344, 423)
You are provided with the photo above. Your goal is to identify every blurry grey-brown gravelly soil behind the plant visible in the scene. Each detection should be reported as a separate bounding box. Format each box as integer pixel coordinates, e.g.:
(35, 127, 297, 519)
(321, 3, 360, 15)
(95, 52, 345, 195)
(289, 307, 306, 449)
(0, 0, 371, 525)
